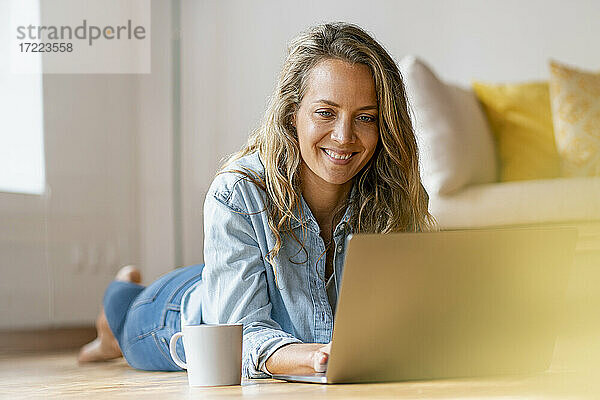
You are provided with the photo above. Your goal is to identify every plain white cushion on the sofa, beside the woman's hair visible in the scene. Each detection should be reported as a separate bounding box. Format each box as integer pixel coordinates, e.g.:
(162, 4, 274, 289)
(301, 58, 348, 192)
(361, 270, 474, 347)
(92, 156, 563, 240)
(399, 56, 497, 196)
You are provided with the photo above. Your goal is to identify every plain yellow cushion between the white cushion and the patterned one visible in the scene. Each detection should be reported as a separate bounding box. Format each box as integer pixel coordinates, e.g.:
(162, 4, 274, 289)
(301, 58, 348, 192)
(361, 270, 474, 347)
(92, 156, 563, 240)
(473, 82, 560, 181)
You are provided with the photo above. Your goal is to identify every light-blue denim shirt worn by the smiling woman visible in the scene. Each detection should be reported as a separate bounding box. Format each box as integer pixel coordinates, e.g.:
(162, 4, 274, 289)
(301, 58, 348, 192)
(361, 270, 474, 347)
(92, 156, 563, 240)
(181, 153, 354, 378)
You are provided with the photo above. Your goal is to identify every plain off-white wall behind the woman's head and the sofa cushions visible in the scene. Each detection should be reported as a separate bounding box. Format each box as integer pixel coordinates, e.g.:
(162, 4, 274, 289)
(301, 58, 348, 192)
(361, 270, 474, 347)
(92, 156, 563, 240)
(182, 0, 600, 264)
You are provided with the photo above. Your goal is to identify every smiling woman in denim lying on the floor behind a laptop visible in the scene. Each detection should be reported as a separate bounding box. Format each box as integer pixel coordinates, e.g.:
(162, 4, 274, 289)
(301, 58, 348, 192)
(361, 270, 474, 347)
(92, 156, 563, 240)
(80, 23, 433, 378)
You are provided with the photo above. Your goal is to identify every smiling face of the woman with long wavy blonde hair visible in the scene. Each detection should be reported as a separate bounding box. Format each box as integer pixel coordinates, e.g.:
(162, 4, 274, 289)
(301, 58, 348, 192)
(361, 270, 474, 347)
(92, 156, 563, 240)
(294, 59, 379, 185)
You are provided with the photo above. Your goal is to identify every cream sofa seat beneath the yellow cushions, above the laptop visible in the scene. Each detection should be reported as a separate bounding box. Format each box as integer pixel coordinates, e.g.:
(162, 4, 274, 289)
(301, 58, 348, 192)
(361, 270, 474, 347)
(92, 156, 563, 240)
(429, 177, 600, 229)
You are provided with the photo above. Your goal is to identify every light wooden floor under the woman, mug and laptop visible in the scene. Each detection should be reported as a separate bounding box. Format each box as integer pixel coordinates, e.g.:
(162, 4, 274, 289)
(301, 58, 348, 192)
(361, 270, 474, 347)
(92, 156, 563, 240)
(0, 334, 600, 400)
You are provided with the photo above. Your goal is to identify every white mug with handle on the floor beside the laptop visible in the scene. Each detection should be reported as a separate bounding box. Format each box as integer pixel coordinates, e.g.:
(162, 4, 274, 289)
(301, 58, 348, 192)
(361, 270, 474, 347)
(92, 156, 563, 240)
(169, 324, 243, 386)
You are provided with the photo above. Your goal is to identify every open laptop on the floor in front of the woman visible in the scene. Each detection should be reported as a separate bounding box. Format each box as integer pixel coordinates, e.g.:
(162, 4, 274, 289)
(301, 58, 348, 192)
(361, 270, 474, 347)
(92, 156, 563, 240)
(273, 228, 577, 383)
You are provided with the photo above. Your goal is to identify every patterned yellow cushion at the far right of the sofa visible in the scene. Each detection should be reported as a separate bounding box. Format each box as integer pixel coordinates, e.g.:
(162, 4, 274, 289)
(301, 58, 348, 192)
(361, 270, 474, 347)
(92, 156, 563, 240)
(550, 61, 600, 176)
